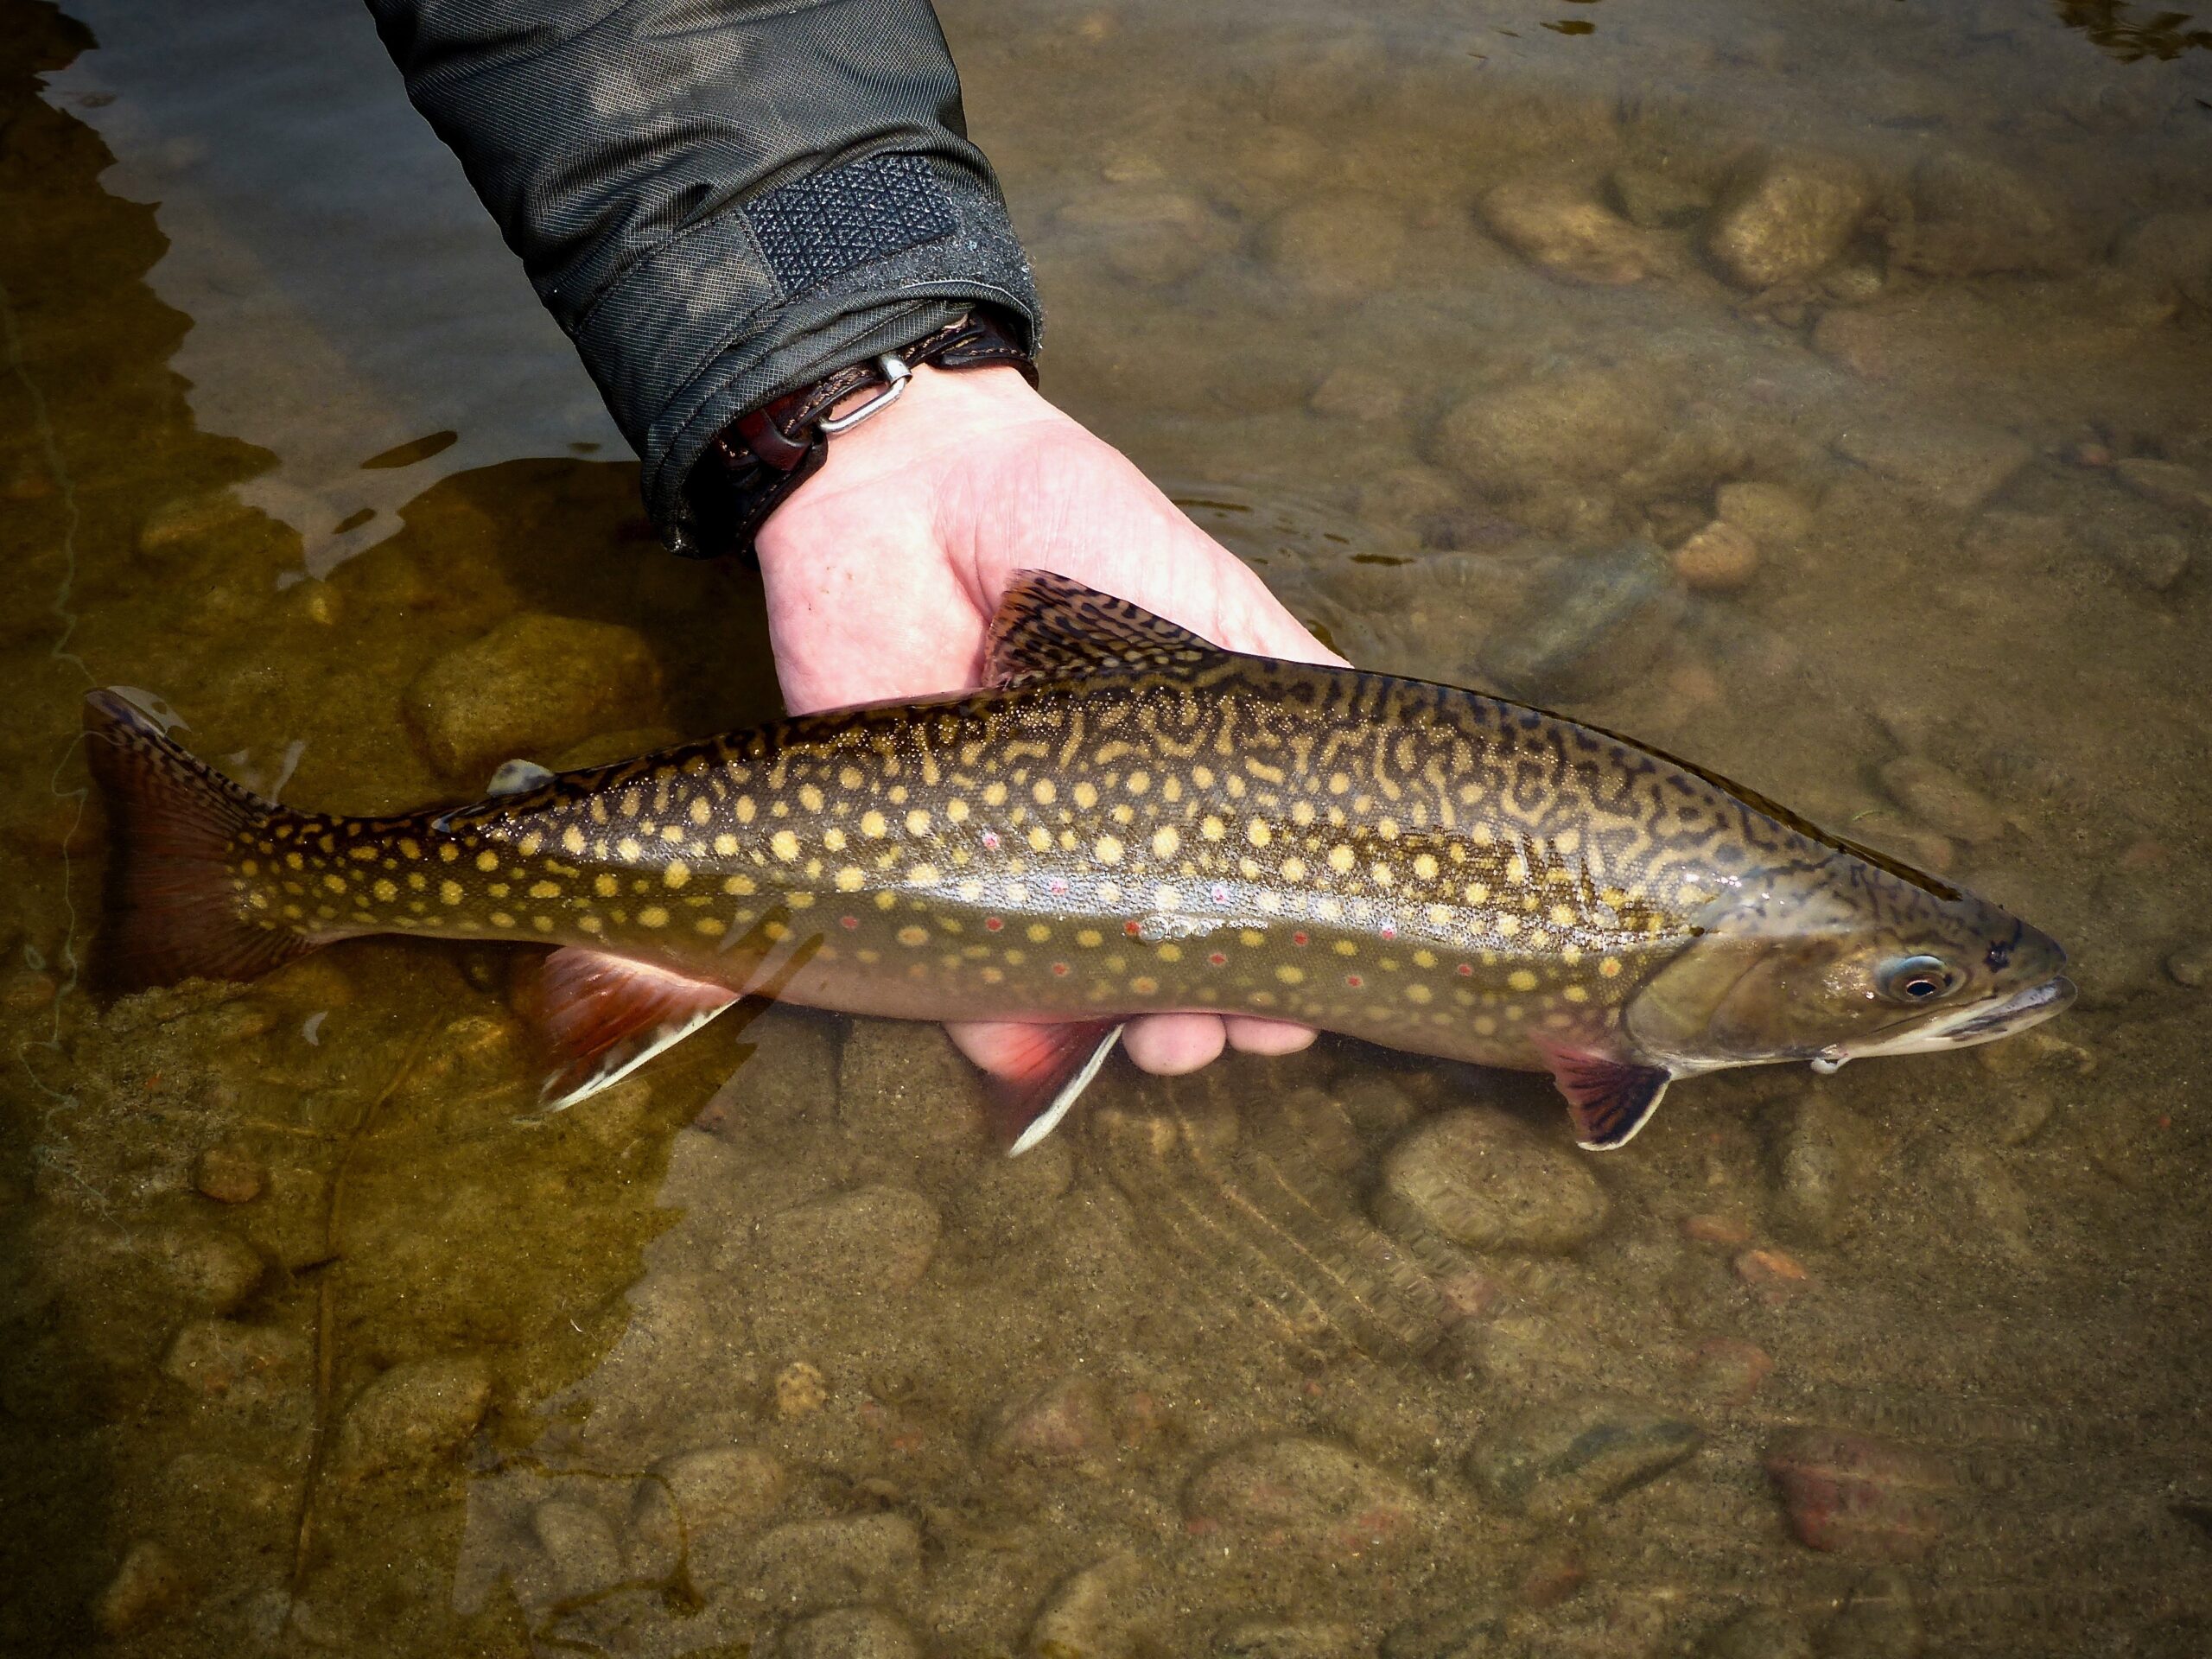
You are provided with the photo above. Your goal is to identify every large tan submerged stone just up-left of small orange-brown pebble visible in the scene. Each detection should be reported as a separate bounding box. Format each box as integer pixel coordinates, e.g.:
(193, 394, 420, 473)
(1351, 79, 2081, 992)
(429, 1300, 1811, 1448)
(1431, 370, 1668, 498)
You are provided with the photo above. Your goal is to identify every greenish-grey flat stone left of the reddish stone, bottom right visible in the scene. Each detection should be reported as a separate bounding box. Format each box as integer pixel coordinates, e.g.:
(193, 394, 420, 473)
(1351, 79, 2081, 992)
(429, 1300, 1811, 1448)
(1466, 1398, 1706, 1522)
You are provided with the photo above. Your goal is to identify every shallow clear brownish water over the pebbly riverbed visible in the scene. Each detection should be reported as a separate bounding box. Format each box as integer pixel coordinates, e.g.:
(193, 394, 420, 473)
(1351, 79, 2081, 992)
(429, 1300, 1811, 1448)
(0, 0, 2212, 1659)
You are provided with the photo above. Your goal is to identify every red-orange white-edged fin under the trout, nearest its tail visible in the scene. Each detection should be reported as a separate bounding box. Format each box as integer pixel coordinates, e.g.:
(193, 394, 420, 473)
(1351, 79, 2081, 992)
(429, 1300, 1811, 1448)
(515, 947, 736, 1113)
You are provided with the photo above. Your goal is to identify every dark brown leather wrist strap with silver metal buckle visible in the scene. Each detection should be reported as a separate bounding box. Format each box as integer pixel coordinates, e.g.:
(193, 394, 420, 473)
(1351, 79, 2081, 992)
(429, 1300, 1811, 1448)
(683, 309, 1038, 560)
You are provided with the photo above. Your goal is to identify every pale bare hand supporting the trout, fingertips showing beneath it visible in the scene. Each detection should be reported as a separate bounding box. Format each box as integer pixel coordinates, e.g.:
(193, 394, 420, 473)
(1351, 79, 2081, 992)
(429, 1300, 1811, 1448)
(757, 367, 1343, 1075)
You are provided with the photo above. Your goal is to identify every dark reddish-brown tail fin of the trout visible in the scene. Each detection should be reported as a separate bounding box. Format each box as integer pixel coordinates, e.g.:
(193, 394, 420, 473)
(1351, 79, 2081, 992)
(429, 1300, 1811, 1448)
(84, 690, 315, 993)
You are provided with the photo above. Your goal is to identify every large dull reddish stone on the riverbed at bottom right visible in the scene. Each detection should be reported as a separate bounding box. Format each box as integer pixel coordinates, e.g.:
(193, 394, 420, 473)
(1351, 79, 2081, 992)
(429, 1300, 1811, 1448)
(1765, 1429, 1948, 1560)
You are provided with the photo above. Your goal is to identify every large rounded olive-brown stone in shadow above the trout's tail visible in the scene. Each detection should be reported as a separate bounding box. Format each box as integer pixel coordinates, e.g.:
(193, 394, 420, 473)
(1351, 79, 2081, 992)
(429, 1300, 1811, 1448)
(404, 613, 661, 787)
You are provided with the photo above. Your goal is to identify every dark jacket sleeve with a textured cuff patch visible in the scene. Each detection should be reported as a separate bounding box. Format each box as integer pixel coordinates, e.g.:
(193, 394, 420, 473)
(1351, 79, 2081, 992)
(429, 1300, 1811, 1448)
(367, 0, 1038, 553)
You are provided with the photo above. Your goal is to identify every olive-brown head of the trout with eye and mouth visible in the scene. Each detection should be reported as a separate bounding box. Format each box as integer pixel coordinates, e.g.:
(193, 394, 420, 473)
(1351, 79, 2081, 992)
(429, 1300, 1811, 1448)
(1626, 852, 2075, 1071)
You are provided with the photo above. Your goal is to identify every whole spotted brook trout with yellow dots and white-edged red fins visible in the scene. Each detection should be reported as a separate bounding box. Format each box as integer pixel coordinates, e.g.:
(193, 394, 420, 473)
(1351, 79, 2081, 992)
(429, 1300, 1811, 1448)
(73, 570, 2075, 1150)
